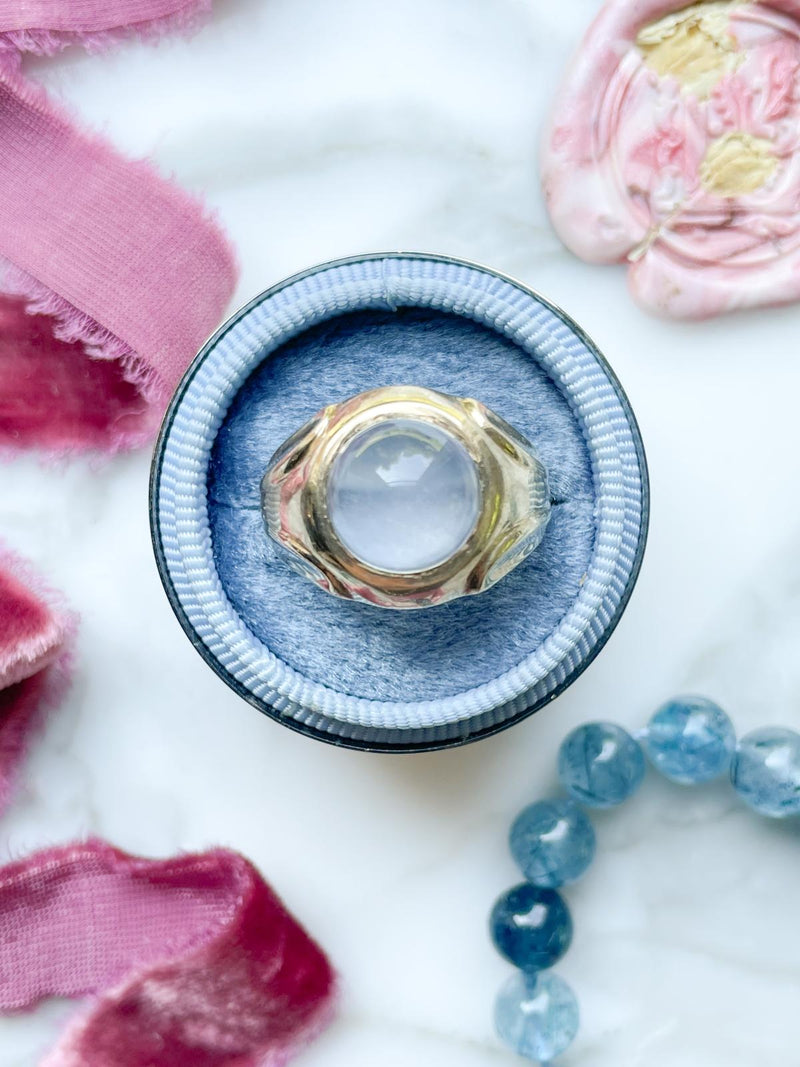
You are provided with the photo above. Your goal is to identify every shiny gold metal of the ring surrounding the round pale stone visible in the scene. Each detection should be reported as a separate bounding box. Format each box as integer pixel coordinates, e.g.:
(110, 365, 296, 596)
(261, 385, 550, 608)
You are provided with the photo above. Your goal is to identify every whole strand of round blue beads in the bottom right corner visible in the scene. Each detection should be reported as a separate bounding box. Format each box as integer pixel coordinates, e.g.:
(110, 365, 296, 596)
(490, 697, 800, 1064)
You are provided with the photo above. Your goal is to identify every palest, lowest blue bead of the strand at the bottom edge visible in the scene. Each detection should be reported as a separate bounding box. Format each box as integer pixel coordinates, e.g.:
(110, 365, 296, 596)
(495, 971, 579, 1064)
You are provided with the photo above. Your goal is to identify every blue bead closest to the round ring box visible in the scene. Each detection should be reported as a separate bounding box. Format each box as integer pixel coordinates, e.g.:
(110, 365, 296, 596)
(558, 722, 644, 808)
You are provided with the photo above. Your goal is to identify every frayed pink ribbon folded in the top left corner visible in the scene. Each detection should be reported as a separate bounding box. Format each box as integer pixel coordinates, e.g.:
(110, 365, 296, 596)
(0, 0, 236, 450)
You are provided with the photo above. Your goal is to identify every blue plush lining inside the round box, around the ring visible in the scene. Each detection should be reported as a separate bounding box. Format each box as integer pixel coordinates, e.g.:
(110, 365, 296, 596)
(208, 308, 595, 701)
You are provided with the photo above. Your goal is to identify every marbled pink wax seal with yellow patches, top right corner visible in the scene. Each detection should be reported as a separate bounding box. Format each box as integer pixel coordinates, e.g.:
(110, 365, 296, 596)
(542, 0, 800, 319)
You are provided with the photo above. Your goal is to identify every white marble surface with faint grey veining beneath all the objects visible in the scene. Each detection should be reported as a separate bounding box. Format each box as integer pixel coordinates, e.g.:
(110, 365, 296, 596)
(0, 0, 800, 1067)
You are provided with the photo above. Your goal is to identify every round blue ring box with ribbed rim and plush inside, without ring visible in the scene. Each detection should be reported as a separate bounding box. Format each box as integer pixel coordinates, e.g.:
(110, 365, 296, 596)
(150, 254, 649, 752)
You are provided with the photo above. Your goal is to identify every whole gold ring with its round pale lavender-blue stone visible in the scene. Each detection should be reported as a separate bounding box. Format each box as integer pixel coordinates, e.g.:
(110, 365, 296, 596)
(261, 385, 550, 608)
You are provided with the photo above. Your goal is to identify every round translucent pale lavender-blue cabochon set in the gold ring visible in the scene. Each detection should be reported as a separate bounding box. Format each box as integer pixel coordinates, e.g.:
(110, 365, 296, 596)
(327, 418, 481, 574)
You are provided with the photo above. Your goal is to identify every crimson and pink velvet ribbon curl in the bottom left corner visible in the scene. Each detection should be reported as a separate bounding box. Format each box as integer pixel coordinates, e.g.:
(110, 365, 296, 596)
(0, 841, 335, 1067)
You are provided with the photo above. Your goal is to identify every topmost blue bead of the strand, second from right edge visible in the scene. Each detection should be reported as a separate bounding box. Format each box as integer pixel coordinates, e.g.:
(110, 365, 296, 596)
(644, 697, 736, 785)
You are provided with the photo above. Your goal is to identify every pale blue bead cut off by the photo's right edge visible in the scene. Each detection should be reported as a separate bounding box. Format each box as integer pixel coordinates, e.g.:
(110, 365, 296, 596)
(731, 727, 800, 818)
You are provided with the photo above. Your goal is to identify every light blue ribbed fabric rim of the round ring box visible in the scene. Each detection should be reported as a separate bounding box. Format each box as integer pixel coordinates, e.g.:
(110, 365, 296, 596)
(151, 254, 649, 751)
